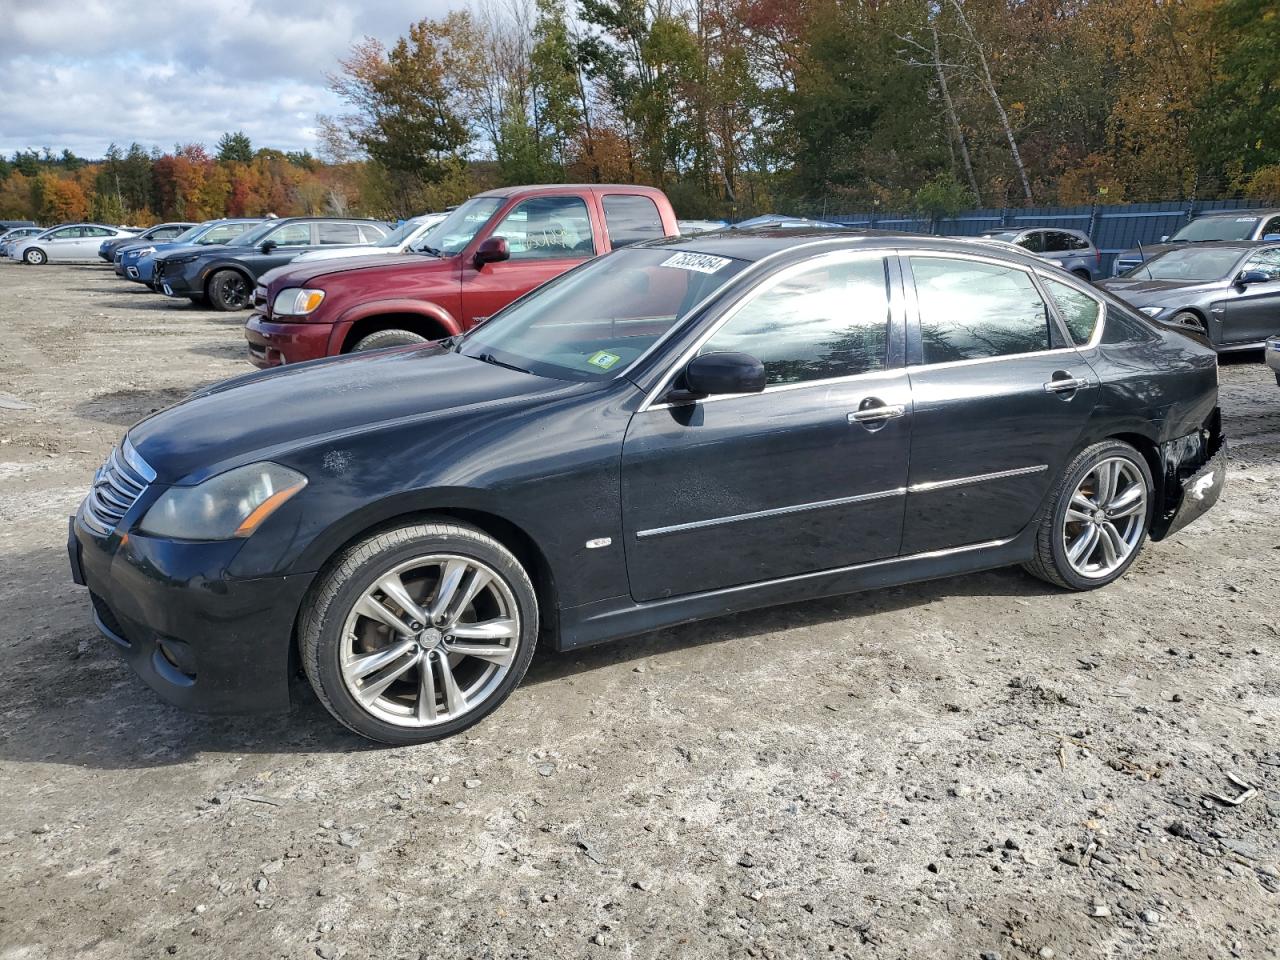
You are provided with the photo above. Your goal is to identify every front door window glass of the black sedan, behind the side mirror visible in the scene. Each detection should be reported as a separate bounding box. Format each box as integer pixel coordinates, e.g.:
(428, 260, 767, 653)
(699, 257, 888, 387)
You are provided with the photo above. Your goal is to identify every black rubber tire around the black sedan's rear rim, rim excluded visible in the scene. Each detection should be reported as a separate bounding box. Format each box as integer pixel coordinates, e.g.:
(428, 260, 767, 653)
(1023, 440, 1155, 590)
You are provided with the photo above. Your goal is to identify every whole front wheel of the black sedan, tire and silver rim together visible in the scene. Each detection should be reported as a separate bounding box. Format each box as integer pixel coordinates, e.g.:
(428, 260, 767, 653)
(298, 518, 538, 745)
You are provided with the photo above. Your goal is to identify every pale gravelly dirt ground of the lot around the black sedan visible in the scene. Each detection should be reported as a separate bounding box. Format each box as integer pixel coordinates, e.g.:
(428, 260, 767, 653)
(0, 261, 1280, 960)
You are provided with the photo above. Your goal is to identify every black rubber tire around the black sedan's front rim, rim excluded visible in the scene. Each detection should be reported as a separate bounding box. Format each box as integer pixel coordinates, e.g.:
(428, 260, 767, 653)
(298, 518, 538, 745)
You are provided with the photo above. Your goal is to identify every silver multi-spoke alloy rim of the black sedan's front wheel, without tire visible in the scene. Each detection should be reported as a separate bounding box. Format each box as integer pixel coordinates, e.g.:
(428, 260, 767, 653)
(339, 554, 521, 727)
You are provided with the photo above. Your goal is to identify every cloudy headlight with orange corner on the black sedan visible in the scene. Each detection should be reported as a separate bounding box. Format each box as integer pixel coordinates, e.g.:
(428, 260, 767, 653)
(138, 462, 307, 540)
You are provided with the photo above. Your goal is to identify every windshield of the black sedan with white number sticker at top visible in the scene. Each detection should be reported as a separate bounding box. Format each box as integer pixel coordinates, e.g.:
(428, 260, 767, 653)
(458, 247, 748, 380)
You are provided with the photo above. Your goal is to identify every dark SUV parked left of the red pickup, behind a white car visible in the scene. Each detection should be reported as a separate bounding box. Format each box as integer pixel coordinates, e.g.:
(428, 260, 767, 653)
(154, 216, 389, 310)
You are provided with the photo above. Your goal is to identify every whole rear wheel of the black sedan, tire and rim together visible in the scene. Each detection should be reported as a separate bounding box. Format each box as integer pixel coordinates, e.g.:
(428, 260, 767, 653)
(1024, 440, 1155, 590)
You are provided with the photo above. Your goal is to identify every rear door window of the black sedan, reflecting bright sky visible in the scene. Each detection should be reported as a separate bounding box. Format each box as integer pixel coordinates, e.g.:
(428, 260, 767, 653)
(911, 257, 1050, 364)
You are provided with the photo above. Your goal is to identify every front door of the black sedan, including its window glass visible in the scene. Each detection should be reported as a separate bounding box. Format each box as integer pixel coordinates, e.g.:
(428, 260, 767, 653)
(622, 252, 911, 600)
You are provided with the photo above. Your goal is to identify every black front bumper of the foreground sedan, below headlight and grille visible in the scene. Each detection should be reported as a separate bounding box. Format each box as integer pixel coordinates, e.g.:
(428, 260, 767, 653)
(67, 516, 314, 713)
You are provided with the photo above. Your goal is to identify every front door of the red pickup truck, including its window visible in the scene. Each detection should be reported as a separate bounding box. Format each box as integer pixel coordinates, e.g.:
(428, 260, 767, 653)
(462, 196, 596, 326)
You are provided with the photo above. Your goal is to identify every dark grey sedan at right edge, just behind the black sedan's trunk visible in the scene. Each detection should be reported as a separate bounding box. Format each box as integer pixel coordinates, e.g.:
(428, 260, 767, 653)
(1100, 241, 1280, 352)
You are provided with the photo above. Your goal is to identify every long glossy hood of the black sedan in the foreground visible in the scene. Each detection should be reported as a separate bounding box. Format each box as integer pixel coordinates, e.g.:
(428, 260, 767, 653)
(129, 344, 582, 483)
